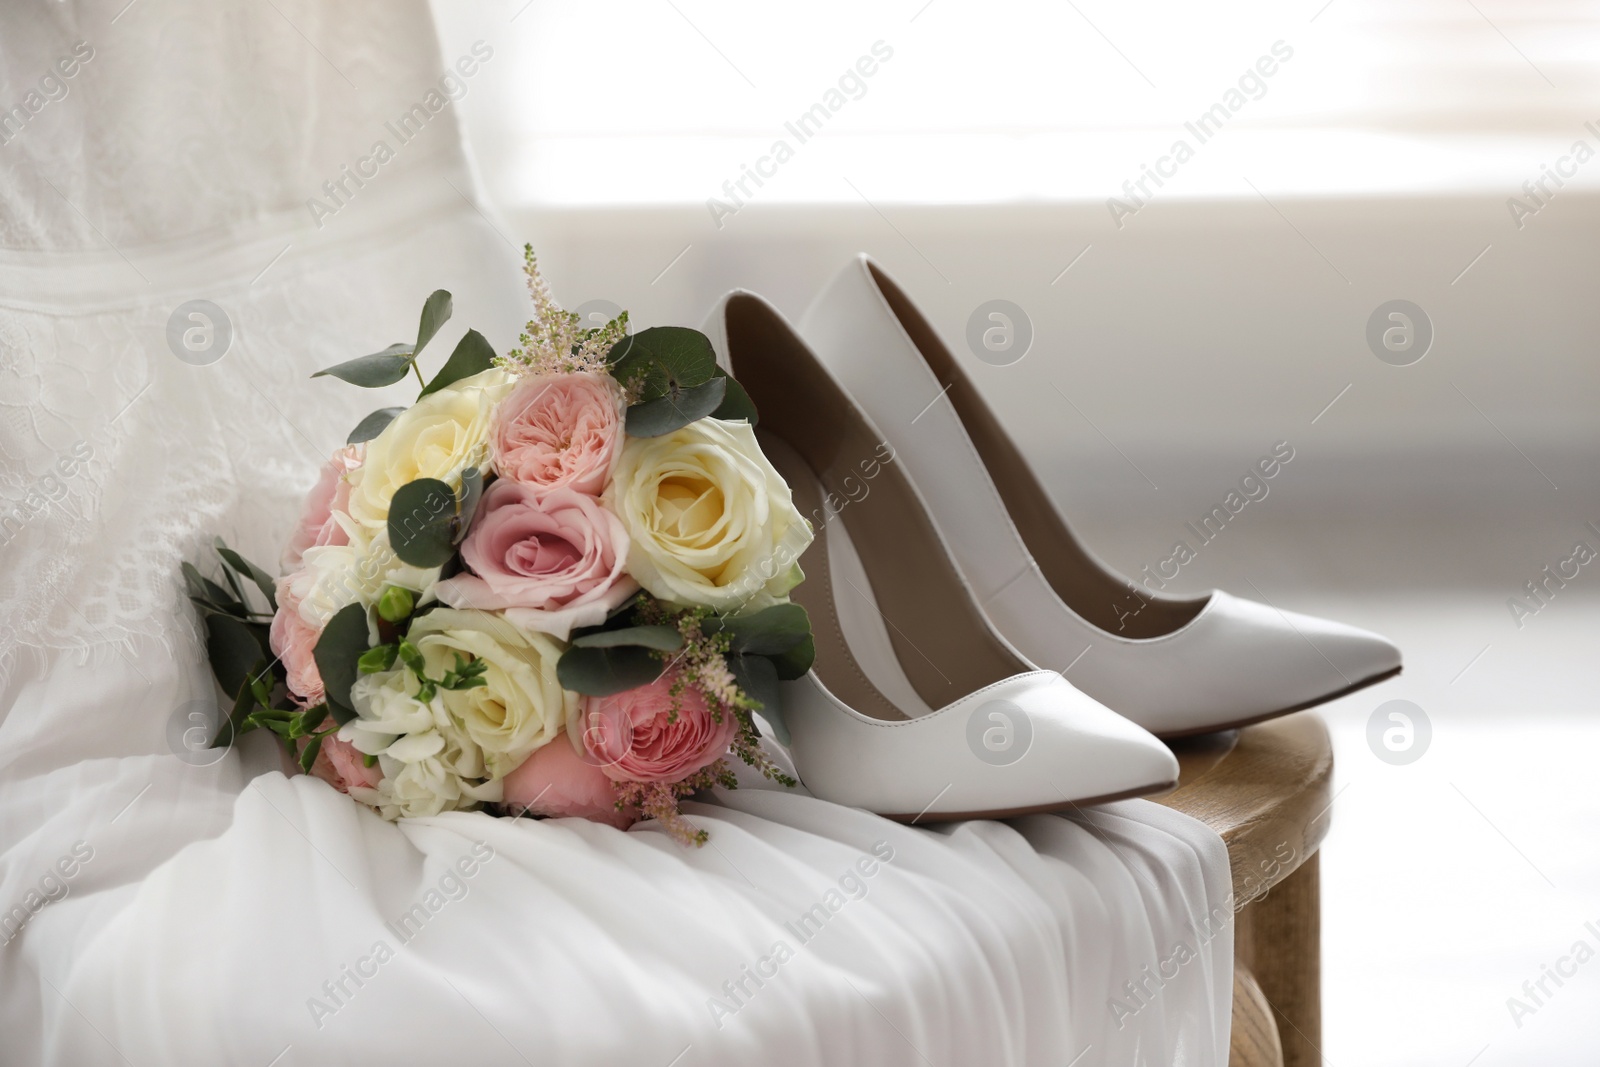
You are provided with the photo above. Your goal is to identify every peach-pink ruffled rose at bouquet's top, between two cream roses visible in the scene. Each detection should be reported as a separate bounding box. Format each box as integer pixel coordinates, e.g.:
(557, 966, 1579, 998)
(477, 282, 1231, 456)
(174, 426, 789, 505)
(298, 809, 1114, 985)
(490, 373, 624, 496)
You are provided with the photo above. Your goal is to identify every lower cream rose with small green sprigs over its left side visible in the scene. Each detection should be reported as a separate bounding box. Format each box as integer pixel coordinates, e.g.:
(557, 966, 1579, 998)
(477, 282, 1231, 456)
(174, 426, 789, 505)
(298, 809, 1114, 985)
(406, 608, 578, 777)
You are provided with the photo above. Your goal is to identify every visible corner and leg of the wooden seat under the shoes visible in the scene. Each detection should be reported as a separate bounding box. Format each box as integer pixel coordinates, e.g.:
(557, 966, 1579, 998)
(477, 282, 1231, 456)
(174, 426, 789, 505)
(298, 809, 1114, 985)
(1155, 712, 1333, 1067)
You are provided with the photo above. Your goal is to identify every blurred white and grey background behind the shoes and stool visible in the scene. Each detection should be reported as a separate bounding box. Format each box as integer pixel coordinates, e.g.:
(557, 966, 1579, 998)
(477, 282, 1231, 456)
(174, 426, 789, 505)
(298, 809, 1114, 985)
(437, 0, 1600, 1067)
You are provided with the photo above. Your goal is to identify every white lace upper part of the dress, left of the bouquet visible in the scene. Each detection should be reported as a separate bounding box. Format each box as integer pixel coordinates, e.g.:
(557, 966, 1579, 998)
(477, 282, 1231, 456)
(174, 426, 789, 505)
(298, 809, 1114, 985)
(0, 3, 522, 662)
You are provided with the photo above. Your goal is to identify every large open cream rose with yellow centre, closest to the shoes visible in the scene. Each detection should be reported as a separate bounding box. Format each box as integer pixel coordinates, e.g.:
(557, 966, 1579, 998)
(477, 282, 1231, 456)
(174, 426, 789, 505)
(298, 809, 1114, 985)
(605, 419, 811, 611)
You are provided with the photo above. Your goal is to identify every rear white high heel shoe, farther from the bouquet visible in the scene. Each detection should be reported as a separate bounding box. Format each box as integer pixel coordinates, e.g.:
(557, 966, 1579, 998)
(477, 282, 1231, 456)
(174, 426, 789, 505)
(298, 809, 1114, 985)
(802, 256, 1400, 737)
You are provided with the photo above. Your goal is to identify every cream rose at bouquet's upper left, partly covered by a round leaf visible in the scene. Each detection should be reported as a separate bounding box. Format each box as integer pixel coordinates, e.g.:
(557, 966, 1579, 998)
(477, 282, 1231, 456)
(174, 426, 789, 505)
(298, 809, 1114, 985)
(349, 370, 512, 530)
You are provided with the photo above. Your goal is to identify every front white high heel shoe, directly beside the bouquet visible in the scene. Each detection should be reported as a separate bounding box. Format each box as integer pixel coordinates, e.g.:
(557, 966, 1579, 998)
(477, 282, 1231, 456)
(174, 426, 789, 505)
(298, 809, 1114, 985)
(706, 290, 1178, 822)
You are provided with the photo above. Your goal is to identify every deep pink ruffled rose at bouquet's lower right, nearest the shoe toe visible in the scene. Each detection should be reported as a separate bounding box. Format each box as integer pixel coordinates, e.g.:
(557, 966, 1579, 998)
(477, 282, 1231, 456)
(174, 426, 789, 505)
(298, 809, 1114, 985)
(582, 677, 739, 782)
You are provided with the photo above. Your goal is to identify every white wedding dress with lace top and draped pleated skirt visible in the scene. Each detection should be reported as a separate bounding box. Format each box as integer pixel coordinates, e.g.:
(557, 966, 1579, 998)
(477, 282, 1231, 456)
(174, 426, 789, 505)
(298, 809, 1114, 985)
(0, 0, 1232, 1067)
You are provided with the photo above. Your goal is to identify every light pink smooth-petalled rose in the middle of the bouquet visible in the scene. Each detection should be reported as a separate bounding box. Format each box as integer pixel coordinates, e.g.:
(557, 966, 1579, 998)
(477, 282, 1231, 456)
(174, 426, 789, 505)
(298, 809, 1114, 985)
(435, 478, 638, 641)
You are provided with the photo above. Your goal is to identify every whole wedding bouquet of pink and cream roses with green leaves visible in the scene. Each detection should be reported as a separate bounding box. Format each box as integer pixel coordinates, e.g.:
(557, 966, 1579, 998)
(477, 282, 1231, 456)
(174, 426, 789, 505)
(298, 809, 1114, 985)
(184, 248, 813, 843)
